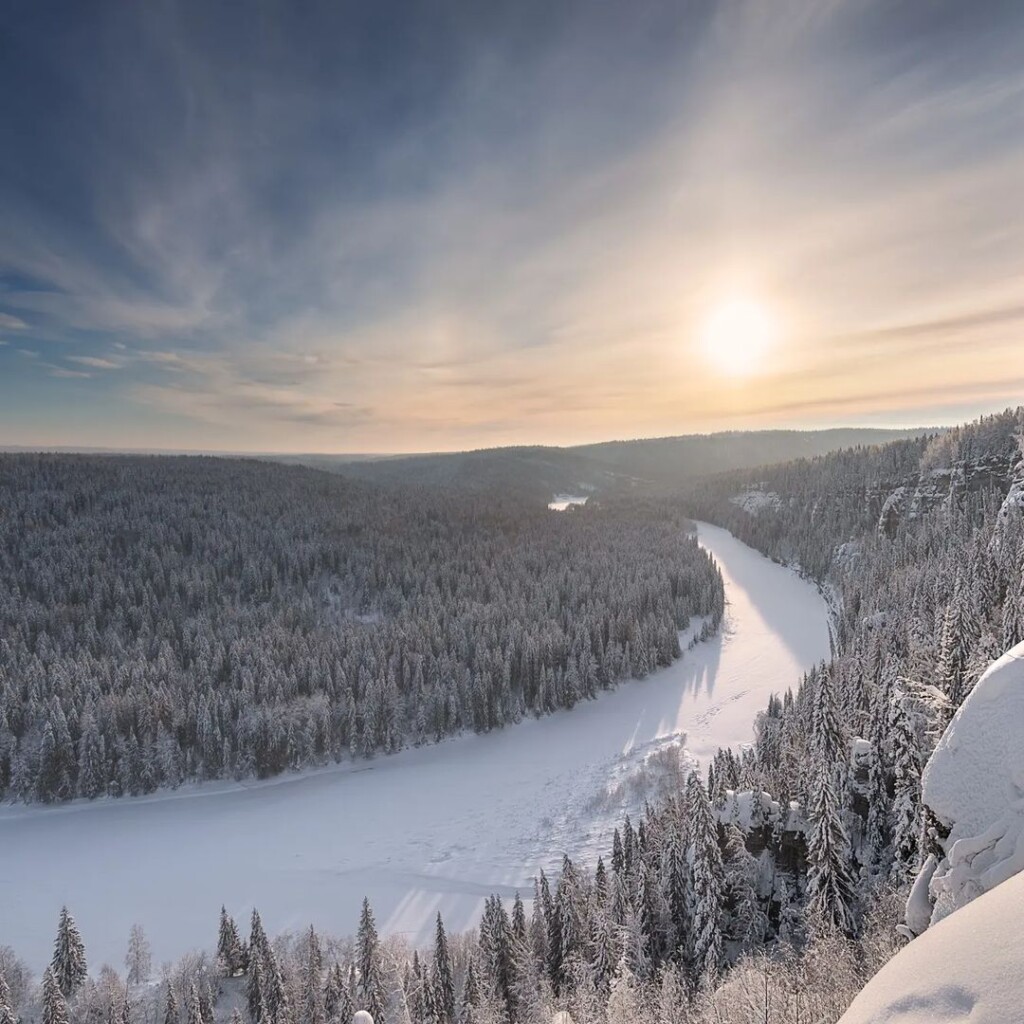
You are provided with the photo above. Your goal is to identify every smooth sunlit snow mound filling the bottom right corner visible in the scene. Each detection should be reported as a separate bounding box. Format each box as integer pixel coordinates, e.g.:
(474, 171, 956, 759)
(840, 874, 1024, 1024)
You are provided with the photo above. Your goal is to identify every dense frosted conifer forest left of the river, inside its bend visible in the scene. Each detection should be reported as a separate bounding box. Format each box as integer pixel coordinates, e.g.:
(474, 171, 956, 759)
(0, 455, 723, 801)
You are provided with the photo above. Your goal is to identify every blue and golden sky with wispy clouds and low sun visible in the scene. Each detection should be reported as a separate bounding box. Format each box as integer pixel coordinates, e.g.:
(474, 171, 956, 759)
(0, 0, 1024, 453)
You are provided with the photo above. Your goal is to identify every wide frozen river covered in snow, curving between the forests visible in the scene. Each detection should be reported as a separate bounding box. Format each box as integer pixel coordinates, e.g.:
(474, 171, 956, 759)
(0, 524, 828, 969)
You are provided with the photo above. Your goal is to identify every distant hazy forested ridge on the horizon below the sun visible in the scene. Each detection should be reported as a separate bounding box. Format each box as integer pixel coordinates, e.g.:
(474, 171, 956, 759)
(325, 428, 925, 501)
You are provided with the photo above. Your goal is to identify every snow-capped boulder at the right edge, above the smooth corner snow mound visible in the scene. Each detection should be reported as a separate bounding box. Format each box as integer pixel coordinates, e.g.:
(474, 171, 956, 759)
(919, 643, 1024, 924)
